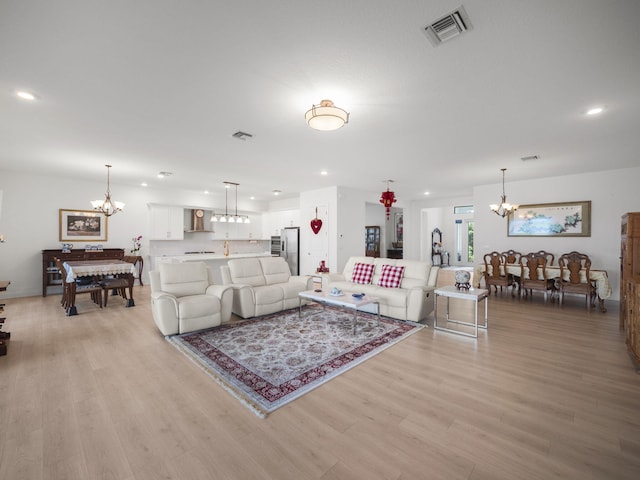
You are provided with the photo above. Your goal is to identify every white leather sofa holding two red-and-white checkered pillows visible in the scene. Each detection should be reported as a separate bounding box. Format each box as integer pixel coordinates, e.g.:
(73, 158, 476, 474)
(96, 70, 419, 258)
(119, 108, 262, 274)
(322, 257, 440, 322)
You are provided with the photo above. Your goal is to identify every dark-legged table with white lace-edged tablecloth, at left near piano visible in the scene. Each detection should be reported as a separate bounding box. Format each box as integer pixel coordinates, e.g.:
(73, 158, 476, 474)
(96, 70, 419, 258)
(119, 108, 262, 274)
(64, 259, 138, 316)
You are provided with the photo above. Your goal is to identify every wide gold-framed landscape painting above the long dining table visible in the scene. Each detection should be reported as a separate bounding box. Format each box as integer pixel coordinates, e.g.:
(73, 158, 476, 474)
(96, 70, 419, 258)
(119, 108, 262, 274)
(507, 200, 591, 237)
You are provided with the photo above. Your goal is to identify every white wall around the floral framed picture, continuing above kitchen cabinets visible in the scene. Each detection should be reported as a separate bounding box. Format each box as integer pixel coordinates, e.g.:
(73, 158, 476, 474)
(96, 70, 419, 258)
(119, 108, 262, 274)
(0, 171, 267, 297)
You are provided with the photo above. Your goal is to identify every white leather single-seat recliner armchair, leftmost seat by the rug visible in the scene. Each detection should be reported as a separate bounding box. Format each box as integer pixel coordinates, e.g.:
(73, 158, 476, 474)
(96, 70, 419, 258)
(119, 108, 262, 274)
(149, 262, 233, 336)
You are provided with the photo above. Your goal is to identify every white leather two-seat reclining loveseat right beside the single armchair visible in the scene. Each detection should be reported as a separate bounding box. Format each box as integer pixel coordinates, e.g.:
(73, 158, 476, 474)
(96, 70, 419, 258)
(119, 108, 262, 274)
(220, 257, 313, 318)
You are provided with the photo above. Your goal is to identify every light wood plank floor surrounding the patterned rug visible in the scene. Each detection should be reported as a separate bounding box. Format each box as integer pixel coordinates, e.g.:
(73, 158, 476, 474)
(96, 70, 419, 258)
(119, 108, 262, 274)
(0, 286, 640, 480)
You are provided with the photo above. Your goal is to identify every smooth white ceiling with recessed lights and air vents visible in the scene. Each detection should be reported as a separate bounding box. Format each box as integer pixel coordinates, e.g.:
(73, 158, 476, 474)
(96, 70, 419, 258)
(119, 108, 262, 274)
(0, 0, 640, 201)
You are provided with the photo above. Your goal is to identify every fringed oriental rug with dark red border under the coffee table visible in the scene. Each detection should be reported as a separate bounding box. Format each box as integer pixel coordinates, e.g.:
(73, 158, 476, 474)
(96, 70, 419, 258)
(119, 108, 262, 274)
(167, 304, 424, 418)
